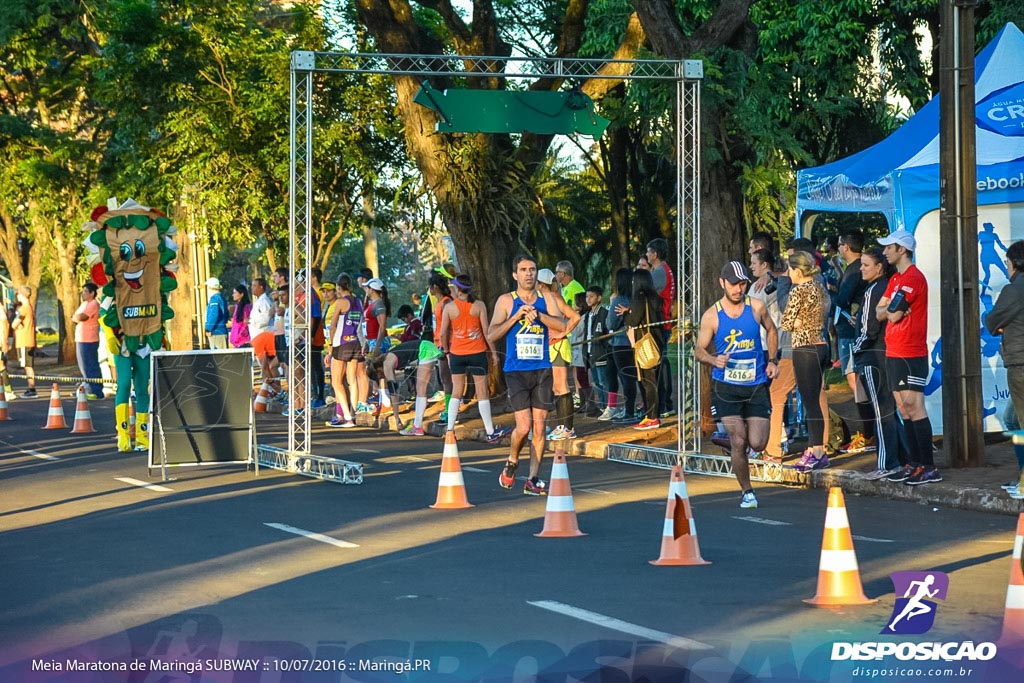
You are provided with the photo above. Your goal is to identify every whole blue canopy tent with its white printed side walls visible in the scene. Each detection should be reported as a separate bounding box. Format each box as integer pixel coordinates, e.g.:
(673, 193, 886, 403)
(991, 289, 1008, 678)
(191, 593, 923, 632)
(797, 24, 1024, 429)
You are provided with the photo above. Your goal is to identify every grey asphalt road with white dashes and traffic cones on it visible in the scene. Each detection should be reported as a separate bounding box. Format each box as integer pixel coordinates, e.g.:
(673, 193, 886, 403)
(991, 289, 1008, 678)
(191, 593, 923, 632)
(0, 399, 1015, 681)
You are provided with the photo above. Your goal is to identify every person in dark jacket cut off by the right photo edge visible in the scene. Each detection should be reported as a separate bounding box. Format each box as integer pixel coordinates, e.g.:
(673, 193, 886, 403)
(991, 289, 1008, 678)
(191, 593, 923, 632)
(985, 241, 1024, 499)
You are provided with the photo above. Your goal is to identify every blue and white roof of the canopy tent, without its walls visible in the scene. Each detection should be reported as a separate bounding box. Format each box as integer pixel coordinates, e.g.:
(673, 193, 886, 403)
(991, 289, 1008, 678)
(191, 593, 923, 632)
(797, 24, 1024, 231)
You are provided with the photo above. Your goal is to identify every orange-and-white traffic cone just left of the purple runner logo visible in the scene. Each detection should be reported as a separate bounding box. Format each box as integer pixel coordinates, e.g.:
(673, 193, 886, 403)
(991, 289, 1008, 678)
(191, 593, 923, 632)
(804, 486, 878, 607)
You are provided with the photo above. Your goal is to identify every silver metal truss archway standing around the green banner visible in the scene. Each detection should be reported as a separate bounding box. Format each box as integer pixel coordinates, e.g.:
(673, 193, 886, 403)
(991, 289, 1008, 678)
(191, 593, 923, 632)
(288, 50, 703, 455)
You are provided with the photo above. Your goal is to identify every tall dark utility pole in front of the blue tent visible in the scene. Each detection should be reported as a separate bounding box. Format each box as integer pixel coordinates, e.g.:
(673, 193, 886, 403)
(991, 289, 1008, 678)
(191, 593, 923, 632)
(939, 0, 985, 467)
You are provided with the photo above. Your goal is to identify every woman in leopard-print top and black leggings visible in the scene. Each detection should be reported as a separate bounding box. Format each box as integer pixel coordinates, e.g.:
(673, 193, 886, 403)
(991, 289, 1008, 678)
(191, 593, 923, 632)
(780, 251, 829, 472)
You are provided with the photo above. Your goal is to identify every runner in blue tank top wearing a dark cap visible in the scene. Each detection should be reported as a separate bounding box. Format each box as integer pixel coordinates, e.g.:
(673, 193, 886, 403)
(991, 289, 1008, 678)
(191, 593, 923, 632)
(694, 261, 778, 508)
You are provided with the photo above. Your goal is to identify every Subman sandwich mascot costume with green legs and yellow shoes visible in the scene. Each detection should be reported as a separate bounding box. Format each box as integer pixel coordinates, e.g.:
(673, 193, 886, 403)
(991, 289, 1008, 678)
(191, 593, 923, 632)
(86, 199, 177, 453)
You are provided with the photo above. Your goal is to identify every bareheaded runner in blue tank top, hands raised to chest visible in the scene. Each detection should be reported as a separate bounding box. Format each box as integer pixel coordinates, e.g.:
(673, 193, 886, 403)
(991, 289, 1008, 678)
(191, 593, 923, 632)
(487, 255, 565, 496)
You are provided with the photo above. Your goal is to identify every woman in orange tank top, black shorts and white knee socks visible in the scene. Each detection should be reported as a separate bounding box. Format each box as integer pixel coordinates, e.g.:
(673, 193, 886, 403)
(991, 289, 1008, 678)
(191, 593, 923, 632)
(438, 274, 512, 443)
